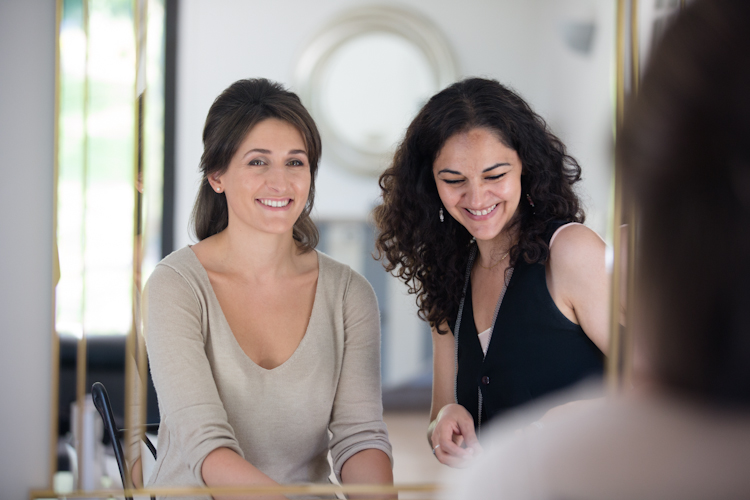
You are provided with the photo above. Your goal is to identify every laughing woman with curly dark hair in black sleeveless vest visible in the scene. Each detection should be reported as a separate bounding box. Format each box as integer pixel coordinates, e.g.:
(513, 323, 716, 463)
(374, 78, 609, 466)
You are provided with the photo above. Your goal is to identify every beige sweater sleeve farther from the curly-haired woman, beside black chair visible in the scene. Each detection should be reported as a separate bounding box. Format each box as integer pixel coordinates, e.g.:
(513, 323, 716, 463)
(143, 264, 244, 484)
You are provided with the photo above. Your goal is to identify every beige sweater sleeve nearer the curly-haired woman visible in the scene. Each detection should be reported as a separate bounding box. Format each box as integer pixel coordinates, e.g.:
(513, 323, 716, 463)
(329, 271, 393, 482)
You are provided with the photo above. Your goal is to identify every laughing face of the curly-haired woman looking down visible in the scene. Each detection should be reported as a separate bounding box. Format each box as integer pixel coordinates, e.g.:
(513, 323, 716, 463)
(432, 128, 522, 244)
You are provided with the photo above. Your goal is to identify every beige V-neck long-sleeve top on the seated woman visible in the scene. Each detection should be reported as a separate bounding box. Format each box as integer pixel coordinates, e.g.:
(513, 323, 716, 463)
(144, 247, 392, 492)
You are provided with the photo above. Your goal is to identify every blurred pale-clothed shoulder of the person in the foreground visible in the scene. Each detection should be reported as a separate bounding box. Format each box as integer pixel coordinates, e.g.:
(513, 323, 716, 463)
(446, 386, 750, 500)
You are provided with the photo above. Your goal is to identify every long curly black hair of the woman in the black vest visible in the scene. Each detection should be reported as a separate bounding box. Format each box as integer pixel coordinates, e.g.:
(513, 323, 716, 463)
(374, 78, 585, 334)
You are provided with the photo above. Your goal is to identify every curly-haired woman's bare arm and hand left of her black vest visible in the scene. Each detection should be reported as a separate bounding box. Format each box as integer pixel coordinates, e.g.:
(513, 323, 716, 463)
(427, 326, 482, 467)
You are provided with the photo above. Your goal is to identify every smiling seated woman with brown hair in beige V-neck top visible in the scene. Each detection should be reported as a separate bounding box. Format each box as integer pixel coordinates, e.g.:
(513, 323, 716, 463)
(144, 79, 392, 498)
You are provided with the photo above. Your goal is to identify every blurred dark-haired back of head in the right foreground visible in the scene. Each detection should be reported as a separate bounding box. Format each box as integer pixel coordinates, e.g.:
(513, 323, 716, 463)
(617, 0, 750, 407)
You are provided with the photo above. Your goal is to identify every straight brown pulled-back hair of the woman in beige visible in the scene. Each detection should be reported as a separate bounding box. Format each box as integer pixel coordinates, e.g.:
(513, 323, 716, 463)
(192, 78, 321, 251)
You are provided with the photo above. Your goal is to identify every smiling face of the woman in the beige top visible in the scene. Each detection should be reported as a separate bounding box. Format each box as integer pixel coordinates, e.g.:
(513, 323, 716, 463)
(209, 118, 311, 234)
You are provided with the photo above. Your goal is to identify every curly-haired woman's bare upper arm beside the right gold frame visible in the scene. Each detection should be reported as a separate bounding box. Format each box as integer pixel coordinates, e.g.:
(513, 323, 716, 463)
(547, 224, 610, 355)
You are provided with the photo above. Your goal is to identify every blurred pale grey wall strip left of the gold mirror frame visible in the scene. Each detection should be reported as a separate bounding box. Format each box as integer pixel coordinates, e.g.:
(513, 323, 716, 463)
(0, 0, 55, 499)
